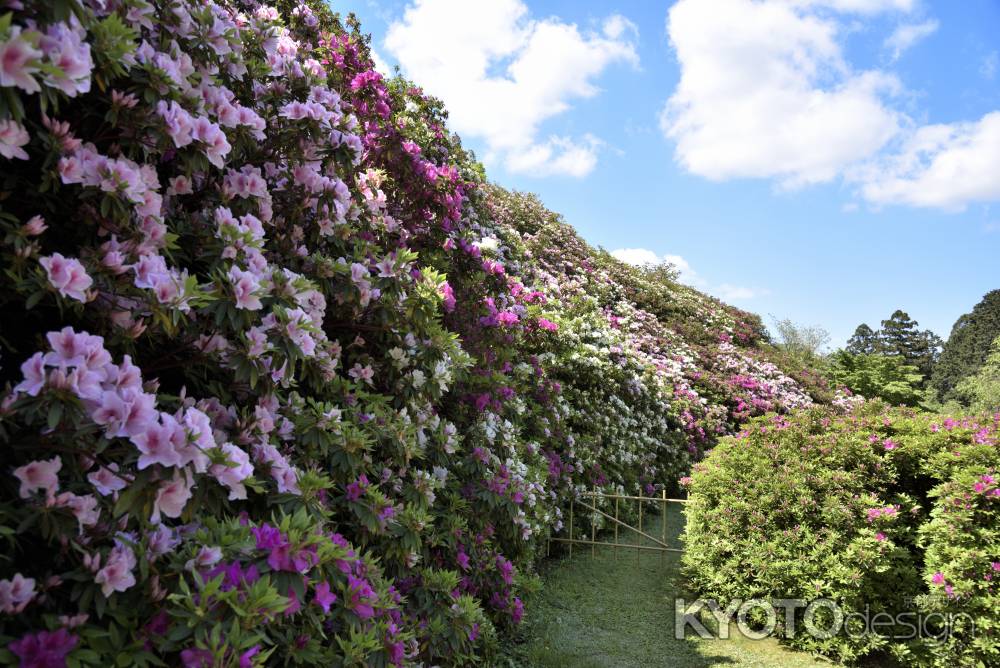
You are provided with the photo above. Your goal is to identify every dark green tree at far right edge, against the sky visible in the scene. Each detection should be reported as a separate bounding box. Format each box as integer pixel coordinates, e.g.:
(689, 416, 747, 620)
(931, 290, 1000, 399)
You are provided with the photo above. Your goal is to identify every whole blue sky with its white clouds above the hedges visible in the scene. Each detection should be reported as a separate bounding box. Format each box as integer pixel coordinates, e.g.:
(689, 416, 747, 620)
(332, 0, 1000, 346)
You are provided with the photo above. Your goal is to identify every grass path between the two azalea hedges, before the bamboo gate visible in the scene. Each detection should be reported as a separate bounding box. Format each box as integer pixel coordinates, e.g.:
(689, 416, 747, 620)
(499, 504, 831, 668)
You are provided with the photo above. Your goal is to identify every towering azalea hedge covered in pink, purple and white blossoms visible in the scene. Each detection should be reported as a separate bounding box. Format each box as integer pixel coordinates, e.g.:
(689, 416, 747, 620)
(0, 0, 829, 668)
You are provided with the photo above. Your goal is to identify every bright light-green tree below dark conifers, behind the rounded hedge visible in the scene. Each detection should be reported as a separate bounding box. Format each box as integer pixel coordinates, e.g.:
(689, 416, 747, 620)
(828, 350, 923, 406)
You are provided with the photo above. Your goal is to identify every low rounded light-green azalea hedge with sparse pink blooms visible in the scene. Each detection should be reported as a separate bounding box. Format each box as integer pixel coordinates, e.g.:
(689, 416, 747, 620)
(683, 402, 1000, 668)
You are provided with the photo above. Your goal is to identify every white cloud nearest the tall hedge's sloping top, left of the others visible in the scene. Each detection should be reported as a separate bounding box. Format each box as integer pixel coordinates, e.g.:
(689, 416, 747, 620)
(385, 0, 639, 177)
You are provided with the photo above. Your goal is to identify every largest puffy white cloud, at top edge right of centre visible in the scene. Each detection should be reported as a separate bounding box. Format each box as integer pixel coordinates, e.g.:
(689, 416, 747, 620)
(660, 0, 911, 187)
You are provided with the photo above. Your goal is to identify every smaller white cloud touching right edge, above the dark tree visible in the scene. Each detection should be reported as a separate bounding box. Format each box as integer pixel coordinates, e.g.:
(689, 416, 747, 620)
(855, 111, 1000, 211)
